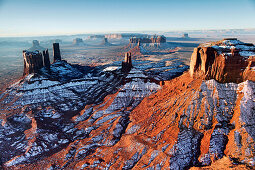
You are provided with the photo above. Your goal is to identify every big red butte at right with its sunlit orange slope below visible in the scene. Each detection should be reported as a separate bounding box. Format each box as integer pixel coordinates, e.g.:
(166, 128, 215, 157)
(0, 39, 255, 169)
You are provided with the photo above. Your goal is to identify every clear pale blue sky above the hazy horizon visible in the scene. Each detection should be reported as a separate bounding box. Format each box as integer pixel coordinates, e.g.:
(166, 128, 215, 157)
(0, 0, 255, 37)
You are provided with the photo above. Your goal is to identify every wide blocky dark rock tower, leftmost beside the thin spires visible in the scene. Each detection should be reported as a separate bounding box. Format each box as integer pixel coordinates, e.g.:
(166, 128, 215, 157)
(23, 50, 43, 75)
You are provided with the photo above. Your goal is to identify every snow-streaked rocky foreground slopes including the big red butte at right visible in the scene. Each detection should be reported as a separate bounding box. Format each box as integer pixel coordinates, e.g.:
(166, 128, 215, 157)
(0, 39, 255, 170)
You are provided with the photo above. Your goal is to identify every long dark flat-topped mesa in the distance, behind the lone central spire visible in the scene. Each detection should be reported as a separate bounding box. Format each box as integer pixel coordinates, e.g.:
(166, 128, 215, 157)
(129, 35, 166, 44)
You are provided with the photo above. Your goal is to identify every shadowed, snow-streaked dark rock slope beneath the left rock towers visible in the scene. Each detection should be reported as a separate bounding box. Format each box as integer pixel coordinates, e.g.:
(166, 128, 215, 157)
(0, 55, 160, 168)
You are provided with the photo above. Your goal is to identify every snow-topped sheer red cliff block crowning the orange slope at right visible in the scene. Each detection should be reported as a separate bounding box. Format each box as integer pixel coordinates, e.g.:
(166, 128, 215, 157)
(190, 38, 255, 83)
